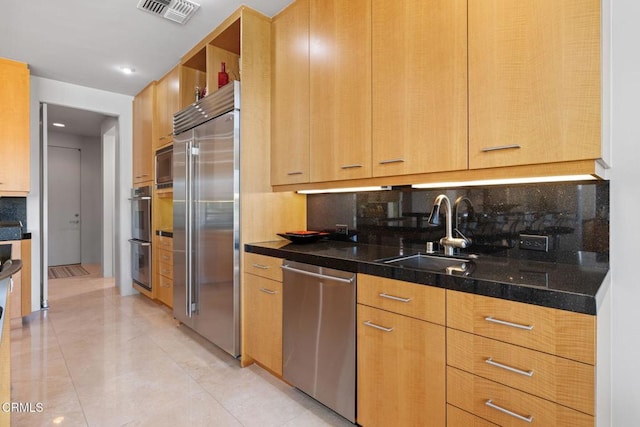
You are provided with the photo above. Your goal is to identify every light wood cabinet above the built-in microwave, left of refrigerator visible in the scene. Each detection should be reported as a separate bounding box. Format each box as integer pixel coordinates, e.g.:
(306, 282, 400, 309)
(153, 65, 181, 149)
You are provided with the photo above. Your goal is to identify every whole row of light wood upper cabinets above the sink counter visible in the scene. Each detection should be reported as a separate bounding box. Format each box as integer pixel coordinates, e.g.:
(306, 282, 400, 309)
(272, 0, 610, 190)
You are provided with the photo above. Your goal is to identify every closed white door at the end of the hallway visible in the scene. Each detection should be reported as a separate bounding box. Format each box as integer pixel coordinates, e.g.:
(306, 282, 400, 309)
(48, 146, 81, 266)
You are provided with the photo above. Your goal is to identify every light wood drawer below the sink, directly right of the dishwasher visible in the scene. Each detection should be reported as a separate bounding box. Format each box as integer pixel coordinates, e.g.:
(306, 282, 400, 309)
(358, 274, 445, 325)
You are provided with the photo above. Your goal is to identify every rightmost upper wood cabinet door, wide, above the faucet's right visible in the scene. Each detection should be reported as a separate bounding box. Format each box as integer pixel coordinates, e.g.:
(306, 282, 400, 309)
(469, 0, 601, 169)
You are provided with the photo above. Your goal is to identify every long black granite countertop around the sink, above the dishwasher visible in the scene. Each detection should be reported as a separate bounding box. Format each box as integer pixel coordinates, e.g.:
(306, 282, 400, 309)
(245, 240, 609, 315)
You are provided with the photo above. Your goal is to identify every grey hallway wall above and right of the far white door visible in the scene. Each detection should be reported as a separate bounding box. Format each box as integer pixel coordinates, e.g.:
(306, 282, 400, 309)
(48, 131, 102, 264)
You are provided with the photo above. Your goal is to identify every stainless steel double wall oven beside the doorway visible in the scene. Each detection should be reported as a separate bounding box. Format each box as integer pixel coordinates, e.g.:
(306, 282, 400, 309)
(129, 186, 152, 290)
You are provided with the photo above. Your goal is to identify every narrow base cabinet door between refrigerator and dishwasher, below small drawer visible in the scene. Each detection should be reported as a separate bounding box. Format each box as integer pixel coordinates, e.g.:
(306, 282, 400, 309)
(244, 273, 282, 375)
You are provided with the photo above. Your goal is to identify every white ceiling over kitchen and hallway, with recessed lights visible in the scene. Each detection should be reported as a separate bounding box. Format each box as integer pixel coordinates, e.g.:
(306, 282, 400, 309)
(0, 0, 292, 136)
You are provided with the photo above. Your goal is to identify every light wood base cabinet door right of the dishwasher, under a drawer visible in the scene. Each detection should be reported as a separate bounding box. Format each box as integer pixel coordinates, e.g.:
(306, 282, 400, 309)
(357, 304, 445, 427)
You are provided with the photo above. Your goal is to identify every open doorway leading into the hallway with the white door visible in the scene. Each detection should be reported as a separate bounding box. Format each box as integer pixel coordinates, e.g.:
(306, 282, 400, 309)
(41, 104, 118, 300)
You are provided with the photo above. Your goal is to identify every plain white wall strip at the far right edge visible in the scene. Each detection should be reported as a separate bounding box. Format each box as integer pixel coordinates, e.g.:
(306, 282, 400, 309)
(610, 0, 640, 427)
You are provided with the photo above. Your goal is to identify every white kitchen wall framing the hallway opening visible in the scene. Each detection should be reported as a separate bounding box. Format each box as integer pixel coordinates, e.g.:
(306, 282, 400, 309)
(27, 76, 136, 310)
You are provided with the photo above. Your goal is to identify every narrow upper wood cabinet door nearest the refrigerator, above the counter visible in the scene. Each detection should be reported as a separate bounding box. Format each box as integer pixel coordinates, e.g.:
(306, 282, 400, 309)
(271, 0, 309, 185)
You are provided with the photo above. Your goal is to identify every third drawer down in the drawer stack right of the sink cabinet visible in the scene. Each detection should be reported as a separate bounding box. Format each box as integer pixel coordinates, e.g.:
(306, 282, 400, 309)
(447, 366, 595, 427)
